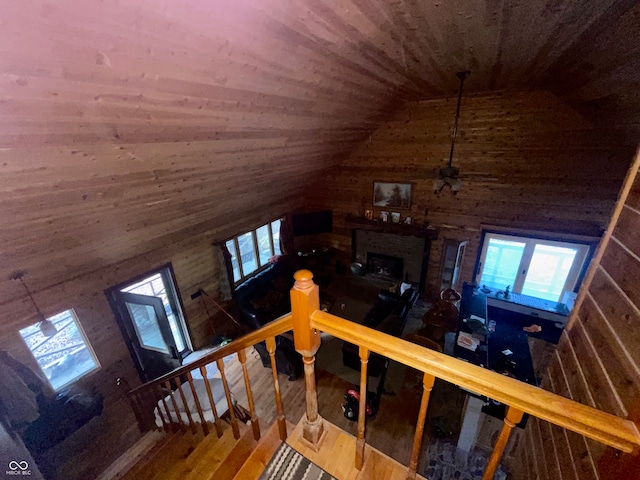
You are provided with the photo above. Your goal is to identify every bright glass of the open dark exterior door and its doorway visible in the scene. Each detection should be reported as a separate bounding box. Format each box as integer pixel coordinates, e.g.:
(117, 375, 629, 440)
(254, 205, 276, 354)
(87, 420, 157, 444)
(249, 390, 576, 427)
(120, 270, 189, 353)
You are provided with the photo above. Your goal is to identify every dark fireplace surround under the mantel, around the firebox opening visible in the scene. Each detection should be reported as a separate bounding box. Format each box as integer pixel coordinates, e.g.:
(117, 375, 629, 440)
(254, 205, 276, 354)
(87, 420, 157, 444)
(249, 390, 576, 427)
(352, 229, 426, 284)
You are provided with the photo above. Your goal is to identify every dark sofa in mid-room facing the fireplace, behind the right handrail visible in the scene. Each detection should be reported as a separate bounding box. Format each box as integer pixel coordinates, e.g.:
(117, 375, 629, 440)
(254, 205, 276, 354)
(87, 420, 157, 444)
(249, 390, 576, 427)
(342, 288, 418, 377)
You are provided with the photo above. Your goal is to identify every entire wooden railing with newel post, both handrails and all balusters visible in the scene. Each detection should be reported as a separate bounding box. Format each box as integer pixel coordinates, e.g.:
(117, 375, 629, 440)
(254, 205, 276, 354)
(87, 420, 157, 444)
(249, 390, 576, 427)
(129, 270, 640, 480)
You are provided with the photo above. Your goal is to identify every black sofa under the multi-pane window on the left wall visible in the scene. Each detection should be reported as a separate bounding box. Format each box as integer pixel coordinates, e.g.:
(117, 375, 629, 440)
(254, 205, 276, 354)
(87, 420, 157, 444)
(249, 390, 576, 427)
(234, 256, 303, 380)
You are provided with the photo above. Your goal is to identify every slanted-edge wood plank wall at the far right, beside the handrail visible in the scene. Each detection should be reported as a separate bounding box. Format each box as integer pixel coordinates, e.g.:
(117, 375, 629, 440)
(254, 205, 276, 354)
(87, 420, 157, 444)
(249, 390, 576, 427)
(519, 156, 640, 480)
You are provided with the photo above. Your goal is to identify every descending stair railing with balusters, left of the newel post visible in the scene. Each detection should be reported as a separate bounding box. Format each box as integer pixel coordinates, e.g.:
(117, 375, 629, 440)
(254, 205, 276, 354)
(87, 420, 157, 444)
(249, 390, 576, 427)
(129, 314, 293, 441)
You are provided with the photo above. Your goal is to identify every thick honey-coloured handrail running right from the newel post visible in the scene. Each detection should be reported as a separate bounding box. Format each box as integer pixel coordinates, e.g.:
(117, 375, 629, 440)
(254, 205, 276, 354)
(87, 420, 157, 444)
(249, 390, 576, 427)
(310, 310, 640, 452)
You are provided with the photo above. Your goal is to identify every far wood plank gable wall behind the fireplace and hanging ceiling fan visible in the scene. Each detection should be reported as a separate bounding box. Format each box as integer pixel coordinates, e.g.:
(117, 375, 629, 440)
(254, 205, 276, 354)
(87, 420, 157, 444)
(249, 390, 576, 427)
(307, 91, 633, 294)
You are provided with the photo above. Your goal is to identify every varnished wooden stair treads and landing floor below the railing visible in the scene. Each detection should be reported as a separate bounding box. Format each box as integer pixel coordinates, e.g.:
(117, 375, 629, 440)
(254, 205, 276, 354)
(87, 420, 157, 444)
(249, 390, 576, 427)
(98, 421, 423, 480)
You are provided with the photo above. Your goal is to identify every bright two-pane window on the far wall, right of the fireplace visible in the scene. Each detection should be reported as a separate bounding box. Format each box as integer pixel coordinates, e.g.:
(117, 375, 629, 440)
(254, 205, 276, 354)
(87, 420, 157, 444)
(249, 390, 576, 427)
(476, 232, 591, 302)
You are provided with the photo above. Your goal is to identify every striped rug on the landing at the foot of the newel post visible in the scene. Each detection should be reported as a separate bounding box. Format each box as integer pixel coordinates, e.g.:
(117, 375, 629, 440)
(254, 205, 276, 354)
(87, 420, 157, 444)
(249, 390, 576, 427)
(259, 442, 336, 480)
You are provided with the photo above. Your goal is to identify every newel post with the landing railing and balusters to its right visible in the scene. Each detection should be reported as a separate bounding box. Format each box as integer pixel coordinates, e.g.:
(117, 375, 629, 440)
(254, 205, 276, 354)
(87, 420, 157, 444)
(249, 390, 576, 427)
(291, 270, 640, 480)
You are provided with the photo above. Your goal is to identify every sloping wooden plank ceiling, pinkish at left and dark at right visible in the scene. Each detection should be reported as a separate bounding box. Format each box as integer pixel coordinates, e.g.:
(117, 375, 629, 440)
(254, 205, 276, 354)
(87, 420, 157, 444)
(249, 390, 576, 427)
(0, 0, 640, 303)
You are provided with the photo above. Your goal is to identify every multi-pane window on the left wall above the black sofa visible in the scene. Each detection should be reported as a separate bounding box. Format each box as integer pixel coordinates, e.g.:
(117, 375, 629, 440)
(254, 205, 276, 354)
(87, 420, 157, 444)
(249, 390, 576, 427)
(226, 219, 282, 283)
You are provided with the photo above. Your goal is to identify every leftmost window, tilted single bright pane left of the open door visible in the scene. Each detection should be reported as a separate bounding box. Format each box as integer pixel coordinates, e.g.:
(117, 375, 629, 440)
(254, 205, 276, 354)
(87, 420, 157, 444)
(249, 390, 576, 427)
(20, 310, 100, 391)
